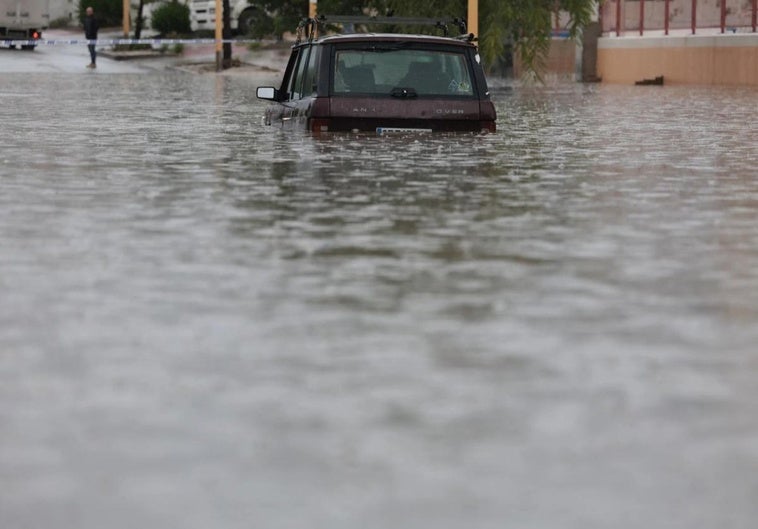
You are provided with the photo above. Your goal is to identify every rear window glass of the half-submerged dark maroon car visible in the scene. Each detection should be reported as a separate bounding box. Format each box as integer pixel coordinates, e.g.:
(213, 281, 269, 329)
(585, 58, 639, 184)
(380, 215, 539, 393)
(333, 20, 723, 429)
(333, 45, 474, 97)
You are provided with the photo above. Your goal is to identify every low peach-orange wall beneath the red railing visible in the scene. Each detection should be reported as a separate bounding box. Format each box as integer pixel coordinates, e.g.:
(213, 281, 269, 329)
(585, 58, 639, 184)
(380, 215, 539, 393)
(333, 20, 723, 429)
(597, 33, 758, 86)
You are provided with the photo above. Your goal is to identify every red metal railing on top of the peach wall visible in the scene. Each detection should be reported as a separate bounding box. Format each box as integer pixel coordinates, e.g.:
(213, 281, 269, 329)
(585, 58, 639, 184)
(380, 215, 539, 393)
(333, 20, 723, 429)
(600, 0, 758, 36)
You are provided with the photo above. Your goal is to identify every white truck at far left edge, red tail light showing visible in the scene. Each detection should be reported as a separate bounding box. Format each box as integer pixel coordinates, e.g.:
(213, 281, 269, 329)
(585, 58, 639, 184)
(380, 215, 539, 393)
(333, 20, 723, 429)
(0, 0, 50, 50)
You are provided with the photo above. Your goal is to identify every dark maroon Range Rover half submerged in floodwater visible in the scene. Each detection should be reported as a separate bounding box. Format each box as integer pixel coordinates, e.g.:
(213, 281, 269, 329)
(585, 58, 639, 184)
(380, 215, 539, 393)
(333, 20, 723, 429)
(257, 19, 496, 133)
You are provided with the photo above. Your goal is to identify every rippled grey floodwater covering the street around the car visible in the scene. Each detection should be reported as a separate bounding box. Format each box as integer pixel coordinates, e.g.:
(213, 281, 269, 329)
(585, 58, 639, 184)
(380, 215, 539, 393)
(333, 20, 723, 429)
(0, 72, 758, 529)
